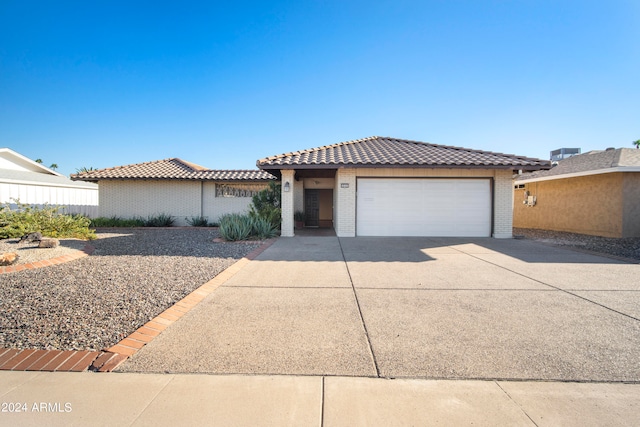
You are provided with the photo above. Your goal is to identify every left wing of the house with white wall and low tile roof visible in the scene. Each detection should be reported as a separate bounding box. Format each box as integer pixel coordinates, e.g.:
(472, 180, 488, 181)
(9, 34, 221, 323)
(71, 158, 275, 225)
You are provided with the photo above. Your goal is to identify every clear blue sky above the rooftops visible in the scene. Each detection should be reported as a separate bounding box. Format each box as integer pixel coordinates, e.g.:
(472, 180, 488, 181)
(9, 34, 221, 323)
(0, 0, 640, 175)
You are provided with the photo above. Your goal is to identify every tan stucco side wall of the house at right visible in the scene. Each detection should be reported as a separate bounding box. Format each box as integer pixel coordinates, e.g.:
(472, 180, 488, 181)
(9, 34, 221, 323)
(513, 173, 638, 241)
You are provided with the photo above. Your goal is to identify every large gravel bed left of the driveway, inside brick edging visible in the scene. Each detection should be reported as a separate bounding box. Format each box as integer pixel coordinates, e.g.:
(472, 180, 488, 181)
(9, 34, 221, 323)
(0, 228, 262, 350)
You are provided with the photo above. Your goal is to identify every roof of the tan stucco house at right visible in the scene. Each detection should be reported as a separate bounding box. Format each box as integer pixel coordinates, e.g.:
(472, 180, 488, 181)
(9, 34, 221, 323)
(517, 148, 640, 182)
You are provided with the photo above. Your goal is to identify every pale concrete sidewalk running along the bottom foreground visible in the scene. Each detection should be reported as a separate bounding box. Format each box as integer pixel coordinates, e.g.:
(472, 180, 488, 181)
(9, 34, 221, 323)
(0, 371, 640, 427)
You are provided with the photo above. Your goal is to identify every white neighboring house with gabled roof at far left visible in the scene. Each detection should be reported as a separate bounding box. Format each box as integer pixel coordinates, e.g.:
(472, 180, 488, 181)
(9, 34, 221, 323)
(0, 148, 98, 217)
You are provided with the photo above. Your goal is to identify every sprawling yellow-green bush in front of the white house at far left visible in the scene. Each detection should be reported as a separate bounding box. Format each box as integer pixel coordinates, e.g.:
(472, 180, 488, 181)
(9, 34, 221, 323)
(0, 200, 96, 240)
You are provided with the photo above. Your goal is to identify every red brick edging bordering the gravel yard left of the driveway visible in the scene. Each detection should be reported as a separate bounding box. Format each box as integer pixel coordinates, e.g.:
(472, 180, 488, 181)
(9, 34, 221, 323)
(0, 238, 277, 372)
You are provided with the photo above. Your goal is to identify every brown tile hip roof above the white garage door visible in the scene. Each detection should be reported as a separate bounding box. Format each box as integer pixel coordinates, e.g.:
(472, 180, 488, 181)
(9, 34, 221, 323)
(257, 136, 551, 170)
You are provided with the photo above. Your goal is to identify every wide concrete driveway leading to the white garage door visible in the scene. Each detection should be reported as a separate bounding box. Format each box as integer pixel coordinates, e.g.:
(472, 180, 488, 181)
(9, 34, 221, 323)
(118, 237, 640, 381)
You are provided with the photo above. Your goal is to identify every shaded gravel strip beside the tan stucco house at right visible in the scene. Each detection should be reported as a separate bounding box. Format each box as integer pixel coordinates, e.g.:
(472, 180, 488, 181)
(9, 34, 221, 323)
(513, 228, 640, 261)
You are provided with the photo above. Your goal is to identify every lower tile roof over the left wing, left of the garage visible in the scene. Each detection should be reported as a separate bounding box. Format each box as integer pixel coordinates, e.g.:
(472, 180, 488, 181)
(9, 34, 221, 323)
(71, 158, 275, 182)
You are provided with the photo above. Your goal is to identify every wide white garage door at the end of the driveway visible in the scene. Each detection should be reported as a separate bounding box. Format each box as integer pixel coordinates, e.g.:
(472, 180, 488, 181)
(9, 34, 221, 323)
(356, 178, 491, 237)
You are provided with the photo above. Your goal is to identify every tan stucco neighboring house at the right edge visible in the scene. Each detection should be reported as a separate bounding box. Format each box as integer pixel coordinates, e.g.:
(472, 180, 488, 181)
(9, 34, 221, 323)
(513, 148, 640, 237)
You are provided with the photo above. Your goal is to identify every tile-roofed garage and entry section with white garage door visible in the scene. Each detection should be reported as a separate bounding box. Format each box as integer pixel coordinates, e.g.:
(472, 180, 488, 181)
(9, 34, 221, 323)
(257, 137, 551, 238)
